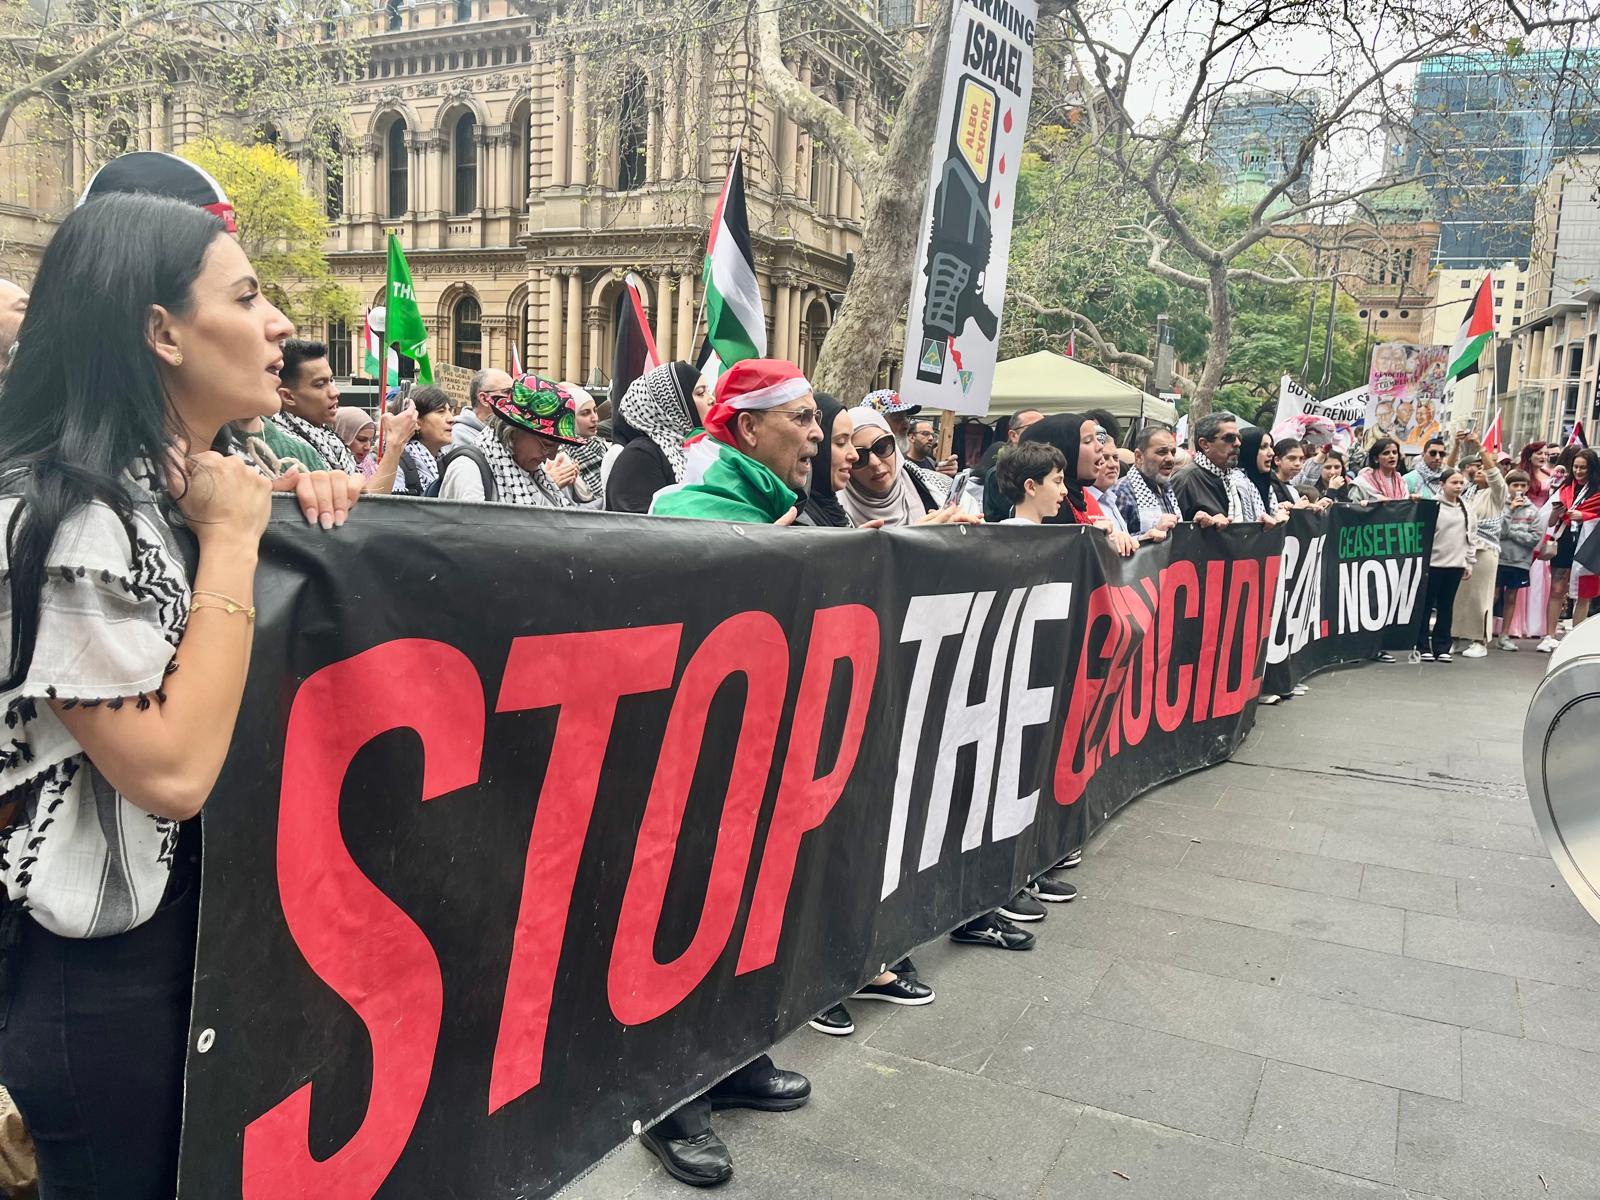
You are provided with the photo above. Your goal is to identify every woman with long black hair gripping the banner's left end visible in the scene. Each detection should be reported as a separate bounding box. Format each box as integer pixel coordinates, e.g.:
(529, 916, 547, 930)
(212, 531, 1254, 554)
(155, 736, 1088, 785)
(0, 195, 354, 1200)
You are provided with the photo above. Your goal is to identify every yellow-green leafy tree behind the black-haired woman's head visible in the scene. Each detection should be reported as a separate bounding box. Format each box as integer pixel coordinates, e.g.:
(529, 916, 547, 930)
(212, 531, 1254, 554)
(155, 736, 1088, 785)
(182, 138, 360, 325)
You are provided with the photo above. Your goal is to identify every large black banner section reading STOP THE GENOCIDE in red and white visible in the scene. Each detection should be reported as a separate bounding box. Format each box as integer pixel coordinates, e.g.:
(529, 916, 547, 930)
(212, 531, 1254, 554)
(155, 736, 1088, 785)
(172, 501, 1401, 1200)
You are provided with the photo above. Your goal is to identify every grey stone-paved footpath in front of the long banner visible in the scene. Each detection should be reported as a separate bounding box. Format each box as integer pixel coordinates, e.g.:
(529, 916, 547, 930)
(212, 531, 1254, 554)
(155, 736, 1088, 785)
(568, 643, 1600, 1200)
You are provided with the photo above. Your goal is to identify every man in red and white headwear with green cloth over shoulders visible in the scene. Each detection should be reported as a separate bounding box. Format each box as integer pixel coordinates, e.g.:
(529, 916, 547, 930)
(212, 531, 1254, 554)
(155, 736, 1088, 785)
(650, 358, 822, 525)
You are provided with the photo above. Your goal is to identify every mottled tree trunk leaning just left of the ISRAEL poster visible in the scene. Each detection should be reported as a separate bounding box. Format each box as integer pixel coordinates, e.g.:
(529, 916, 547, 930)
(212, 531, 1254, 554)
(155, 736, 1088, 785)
(814, 2, 950, 406)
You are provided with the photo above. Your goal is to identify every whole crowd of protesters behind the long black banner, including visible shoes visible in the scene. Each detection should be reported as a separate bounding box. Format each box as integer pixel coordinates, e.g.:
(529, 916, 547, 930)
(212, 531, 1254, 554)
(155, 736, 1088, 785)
(0, 150, 1600, 1200)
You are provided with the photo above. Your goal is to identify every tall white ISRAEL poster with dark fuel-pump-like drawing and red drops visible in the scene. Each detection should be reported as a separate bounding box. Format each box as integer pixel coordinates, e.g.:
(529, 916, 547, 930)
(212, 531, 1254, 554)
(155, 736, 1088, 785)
(901, 0, 1038, 416)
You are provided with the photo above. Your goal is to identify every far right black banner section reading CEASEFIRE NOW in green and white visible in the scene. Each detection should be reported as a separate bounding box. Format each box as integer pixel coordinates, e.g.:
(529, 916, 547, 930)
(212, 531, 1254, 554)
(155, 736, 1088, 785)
(1264, 499, 1438, 694)
